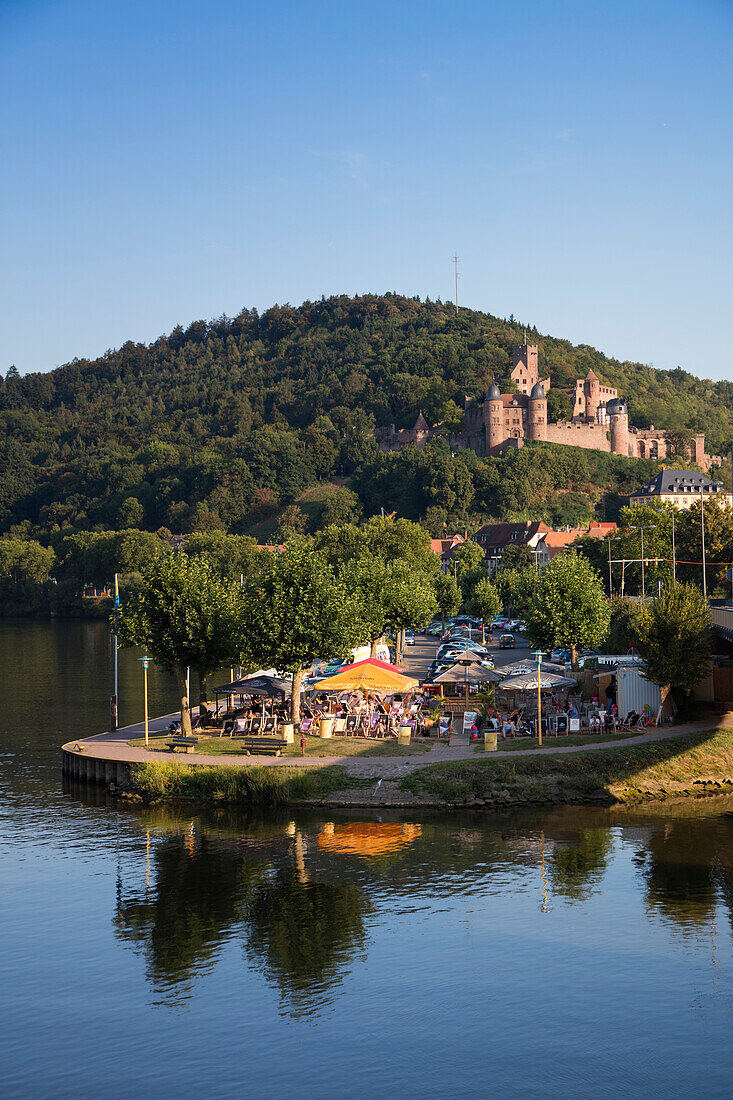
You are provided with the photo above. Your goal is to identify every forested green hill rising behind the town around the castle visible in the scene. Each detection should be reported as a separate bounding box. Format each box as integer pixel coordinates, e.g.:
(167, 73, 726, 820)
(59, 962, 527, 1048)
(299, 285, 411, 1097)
(0, 294, 733, 540)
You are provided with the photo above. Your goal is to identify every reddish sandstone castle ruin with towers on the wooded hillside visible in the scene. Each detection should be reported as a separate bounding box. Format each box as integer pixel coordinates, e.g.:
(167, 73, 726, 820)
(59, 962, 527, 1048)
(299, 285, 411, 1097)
(375, 343, 720, 471)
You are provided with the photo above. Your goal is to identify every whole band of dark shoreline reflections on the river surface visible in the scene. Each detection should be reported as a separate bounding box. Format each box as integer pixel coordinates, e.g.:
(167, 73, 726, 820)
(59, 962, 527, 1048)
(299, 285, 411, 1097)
(79, 788, 733, 1016)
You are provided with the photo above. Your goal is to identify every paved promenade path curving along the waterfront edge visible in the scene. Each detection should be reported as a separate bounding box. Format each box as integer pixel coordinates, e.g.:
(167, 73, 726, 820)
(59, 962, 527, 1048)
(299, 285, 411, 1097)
(64, 714, 733, 779)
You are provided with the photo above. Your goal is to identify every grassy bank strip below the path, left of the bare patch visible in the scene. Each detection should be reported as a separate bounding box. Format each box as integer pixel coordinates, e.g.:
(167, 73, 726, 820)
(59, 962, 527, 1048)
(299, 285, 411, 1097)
(130, 760, 354, 806)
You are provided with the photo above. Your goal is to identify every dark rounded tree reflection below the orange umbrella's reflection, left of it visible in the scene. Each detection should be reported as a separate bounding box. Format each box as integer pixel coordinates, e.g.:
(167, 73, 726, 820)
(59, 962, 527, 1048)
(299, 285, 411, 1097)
(247, 867, 369, 1013)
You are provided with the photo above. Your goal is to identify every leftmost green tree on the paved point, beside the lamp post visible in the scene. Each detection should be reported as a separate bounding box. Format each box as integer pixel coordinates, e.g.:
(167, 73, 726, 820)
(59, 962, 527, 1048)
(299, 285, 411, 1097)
(118, 554, 242, 735)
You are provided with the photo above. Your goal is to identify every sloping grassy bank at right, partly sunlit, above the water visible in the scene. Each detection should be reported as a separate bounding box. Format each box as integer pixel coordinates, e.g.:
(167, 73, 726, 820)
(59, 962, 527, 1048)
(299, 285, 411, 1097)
(401, 729, 733, 804)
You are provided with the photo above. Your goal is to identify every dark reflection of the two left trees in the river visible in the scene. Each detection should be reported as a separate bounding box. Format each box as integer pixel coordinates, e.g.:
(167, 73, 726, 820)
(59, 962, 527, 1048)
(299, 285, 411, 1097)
(114, 834, 368, 1011)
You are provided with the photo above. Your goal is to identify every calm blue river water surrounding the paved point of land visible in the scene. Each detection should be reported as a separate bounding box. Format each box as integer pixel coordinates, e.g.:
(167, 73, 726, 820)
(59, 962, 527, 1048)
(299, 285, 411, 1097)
(0, 622, 733, 1100)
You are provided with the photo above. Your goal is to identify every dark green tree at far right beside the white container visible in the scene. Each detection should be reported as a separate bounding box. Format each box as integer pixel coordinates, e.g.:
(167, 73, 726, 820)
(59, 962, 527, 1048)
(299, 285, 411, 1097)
(635, 584, 712, 699)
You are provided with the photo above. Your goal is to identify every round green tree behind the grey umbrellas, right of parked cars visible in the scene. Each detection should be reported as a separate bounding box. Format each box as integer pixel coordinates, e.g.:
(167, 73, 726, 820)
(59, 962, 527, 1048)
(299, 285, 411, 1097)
(526, 550, 611, 666)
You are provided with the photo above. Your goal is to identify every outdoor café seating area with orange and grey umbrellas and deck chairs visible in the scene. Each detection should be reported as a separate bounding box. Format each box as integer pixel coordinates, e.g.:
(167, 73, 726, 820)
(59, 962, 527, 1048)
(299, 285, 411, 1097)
(157, 647, 658, 754)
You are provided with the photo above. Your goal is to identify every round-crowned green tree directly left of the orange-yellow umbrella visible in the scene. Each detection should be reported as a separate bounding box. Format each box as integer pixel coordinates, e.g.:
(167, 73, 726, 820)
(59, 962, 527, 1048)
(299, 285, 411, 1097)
(241, 541, 367, 722)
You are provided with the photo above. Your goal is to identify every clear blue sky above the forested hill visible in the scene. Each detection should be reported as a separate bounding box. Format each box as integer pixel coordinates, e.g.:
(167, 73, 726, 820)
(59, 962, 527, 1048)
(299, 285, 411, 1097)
(0, 0, 733, 378)
